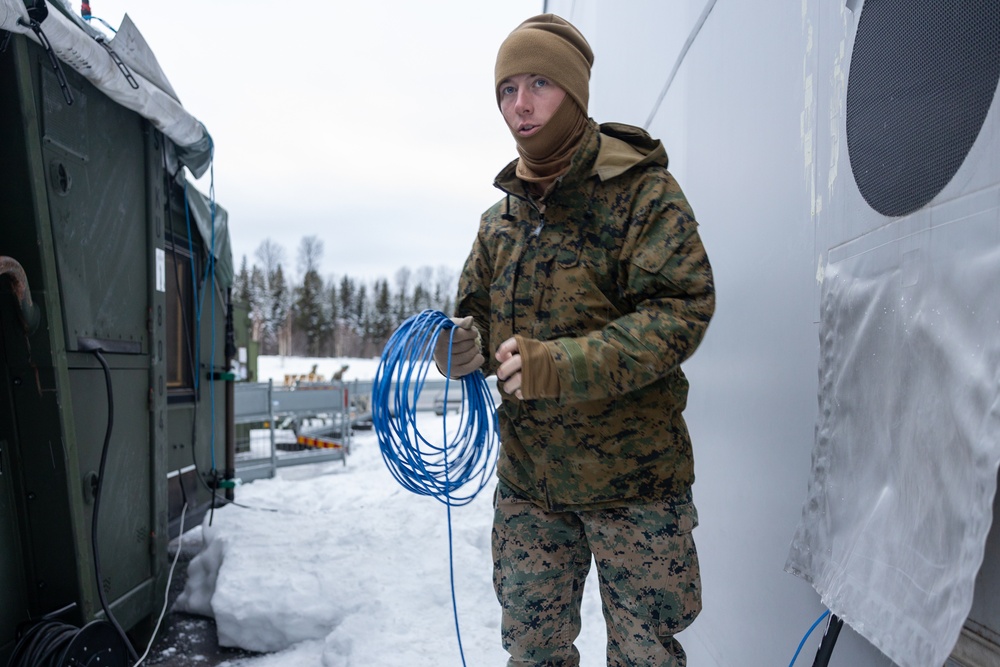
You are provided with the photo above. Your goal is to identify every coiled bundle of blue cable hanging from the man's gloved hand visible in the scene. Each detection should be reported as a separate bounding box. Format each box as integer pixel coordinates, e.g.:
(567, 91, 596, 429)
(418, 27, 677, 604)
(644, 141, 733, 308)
(372, 310, 500, 507)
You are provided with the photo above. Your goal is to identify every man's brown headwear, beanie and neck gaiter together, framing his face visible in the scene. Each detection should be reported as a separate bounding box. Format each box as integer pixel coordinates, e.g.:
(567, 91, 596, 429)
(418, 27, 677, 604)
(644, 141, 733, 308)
(494, 14, 594, 182)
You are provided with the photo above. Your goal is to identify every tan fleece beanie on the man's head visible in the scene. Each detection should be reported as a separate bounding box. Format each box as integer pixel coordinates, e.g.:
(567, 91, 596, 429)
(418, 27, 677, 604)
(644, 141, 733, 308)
(493, 14, 594, 115)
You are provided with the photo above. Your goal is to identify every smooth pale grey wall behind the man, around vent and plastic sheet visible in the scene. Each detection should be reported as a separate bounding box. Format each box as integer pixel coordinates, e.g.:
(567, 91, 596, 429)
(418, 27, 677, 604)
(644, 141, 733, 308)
(545, 0, 1000, 666)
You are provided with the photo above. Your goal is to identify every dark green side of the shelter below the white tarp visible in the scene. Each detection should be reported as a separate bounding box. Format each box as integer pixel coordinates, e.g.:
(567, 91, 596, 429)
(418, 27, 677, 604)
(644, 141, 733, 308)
(0, 35, 228, 664)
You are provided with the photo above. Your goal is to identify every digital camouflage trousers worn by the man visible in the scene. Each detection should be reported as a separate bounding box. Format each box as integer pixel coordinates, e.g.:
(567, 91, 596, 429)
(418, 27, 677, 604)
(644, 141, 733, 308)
(493, 482, 701, 667)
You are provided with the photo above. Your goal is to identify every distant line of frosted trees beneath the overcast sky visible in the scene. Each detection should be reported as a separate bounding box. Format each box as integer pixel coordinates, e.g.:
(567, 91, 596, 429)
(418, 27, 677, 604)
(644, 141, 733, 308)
(233, 236, 456, 357)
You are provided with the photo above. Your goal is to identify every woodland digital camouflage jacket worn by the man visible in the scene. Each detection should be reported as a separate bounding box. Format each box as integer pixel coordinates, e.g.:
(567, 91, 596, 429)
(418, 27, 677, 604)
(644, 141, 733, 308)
(456, 122, 715, 510)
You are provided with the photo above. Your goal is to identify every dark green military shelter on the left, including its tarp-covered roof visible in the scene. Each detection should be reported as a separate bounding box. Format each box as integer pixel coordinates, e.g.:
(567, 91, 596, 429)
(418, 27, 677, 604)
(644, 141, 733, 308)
(0, 0, 235, 665)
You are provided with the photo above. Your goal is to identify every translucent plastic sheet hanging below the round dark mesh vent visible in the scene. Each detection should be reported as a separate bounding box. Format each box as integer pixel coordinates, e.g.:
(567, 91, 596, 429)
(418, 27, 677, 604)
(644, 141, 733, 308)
(786, 187, 1000, 667)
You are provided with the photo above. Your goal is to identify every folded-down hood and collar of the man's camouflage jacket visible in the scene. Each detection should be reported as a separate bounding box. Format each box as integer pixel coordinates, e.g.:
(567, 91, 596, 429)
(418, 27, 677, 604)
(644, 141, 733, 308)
(494, 121, 668, 194)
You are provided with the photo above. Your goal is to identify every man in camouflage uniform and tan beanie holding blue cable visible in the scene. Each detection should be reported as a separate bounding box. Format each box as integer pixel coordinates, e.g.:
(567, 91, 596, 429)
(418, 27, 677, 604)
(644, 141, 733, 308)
(434, 14, 715, 667)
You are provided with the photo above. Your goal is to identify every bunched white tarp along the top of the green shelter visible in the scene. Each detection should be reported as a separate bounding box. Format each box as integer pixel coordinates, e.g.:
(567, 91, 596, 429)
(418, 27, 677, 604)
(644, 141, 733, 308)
(0, 0, 211, 178)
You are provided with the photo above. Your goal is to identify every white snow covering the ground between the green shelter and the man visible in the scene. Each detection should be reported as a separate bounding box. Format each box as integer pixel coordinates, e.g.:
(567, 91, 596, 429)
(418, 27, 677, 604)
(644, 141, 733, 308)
(168, 358, 606, 667)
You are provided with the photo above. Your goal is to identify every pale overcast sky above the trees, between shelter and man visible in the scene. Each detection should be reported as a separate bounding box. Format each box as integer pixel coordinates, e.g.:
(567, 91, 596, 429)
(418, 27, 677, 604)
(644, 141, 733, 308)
(84, 0, 543, 281)
